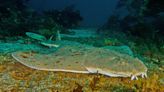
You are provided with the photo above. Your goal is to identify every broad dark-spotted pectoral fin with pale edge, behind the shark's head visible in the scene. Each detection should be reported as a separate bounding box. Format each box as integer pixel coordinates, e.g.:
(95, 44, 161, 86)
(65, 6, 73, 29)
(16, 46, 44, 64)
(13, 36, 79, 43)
(12, 48, 89, 73)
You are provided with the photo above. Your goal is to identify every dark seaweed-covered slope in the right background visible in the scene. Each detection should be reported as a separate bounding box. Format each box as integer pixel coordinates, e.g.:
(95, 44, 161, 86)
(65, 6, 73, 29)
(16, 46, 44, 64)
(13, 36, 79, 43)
(98, 0, 164, 49)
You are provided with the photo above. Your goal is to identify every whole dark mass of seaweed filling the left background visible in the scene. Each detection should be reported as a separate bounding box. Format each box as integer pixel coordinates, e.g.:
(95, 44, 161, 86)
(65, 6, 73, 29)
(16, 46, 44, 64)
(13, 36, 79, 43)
(0, 0, 82, 39)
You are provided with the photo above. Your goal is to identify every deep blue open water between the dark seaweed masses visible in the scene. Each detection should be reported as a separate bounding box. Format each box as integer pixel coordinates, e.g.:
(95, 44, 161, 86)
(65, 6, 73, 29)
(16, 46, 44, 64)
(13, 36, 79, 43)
(29, 0, 118, 27)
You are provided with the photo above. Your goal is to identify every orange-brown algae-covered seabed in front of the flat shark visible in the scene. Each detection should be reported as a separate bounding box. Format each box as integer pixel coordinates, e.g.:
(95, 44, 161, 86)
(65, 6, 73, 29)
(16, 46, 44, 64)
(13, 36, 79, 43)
(0, 33, 164, 92)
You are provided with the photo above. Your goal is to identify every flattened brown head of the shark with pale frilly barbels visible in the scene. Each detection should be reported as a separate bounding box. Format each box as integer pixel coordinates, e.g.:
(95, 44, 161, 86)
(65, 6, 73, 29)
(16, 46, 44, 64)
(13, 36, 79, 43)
(84, 48, 147, 80)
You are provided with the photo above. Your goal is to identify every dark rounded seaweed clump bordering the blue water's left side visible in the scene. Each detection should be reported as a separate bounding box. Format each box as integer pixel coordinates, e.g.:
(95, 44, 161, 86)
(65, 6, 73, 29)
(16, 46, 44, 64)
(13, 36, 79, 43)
(44, 5, 83, 28)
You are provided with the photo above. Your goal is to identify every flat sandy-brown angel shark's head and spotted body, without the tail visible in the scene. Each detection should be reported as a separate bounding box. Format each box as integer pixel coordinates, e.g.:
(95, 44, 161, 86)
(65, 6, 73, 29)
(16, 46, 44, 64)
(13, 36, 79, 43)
(12, 45, 147, 80)
